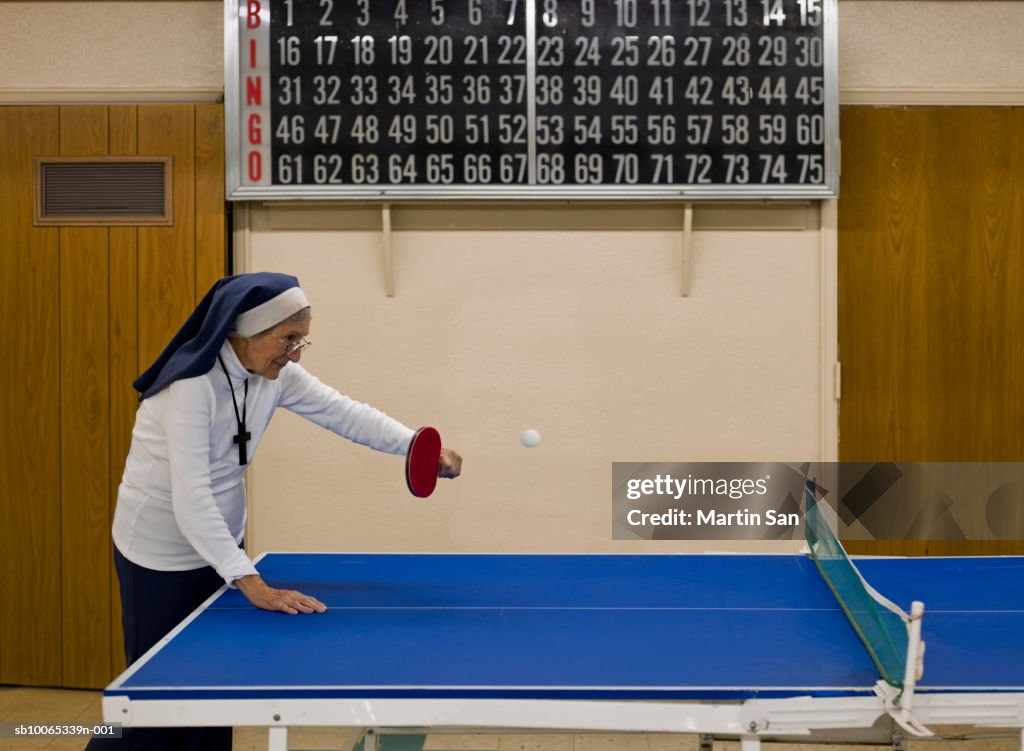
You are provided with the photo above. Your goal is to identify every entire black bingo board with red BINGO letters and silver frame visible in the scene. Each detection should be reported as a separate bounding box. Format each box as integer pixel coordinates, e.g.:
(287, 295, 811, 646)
(226, 0, 838, 200)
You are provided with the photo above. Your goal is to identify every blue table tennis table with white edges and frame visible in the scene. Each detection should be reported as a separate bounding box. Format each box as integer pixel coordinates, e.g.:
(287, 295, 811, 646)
(103, 553, 1024, 751)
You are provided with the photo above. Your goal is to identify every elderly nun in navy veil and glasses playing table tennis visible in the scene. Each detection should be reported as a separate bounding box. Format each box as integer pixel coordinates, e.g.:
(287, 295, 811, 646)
(89, 273, 462, 751)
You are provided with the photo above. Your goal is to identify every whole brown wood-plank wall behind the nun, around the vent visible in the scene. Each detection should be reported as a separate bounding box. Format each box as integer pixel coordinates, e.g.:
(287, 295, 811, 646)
(0, 105, 227, 689)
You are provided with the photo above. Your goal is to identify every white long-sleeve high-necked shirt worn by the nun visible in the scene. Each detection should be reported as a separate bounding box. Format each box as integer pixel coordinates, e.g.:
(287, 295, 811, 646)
(113, 342, 414, 582)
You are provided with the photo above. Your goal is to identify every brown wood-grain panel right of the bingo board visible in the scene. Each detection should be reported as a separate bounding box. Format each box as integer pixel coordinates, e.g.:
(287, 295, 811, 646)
(839, 108, 1024, 554)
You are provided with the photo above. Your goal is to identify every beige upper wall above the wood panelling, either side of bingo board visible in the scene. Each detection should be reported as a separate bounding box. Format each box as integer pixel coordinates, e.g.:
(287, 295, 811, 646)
(0, 0, 1024, 100)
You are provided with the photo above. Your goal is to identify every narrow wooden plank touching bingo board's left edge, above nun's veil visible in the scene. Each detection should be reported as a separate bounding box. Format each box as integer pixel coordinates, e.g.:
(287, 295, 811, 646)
(196, 105, 227, 302)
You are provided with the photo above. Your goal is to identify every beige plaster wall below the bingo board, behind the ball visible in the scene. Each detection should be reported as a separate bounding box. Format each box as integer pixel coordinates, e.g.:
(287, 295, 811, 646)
(248, 201, 822, 552)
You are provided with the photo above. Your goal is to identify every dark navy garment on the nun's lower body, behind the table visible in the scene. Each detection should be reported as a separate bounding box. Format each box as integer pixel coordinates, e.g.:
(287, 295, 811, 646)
(86, 546, 231, 751)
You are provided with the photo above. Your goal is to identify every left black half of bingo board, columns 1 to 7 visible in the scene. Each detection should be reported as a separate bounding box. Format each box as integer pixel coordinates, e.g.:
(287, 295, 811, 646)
(270, 0, 527, 185)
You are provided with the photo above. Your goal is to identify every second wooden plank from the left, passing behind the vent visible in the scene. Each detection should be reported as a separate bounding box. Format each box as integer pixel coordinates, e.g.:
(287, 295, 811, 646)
(60, 107, 112, 686)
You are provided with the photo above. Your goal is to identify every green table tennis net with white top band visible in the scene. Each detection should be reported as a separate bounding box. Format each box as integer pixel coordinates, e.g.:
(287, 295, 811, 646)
(804, 481, 909, 689)
